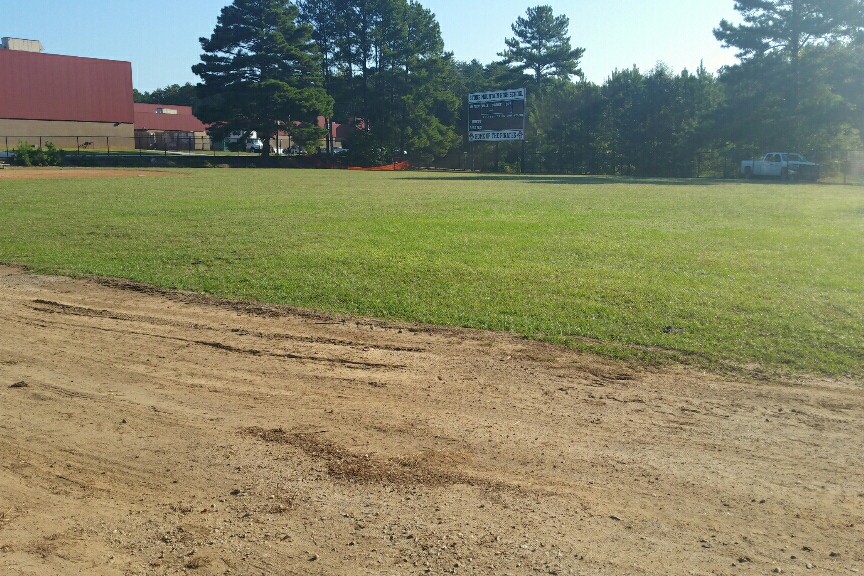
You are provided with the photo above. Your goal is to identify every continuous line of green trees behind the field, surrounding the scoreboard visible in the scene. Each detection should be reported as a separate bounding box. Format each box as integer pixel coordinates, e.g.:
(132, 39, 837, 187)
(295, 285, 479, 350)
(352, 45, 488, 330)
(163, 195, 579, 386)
(138, 0, 864, 176)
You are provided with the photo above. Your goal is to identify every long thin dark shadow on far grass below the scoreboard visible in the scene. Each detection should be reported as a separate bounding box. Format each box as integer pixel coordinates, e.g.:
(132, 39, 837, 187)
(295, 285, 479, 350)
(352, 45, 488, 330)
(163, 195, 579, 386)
(401, 172, 740, 186)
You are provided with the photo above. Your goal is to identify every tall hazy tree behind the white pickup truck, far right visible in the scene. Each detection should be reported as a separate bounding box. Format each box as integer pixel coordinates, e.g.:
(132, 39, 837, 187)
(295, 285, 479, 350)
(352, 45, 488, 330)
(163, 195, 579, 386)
(714, 0, 864, 152)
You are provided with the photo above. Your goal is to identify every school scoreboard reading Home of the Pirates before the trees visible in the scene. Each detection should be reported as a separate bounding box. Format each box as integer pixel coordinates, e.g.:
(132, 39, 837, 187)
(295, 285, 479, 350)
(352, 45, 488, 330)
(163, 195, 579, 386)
(468, 88, 525, 142)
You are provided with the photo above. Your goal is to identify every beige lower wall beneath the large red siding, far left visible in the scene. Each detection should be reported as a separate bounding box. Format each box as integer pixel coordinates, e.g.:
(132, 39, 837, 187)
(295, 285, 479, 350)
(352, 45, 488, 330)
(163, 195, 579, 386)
(0, 118, 135, 151)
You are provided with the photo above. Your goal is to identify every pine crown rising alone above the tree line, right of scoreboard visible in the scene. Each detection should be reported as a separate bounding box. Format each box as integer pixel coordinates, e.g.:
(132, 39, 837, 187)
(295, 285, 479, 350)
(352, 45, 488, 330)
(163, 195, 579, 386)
(498, 5, 585, 85)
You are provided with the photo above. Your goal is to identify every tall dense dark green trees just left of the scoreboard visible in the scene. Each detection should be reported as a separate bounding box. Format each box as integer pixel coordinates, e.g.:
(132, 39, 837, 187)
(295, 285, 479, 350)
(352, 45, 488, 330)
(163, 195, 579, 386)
(301, 0, 459, 160)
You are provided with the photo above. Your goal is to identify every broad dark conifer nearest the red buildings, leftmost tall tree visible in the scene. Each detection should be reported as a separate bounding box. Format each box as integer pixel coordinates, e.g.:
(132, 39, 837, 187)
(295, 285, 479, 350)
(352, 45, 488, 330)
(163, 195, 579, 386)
(192, 0, 333, 155)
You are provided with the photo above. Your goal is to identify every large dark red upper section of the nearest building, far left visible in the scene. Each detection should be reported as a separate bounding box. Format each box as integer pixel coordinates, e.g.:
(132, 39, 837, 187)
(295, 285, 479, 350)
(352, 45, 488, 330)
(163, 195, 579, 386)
(0, 50, 135, 124)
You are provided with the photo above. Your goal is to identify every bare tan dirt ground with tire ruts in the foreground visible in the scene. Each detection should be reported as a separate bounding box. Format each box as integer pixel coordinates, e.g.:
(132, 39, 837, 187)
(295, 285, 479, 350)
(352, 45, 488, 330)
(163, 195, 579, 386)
(0, 266, 864, 575)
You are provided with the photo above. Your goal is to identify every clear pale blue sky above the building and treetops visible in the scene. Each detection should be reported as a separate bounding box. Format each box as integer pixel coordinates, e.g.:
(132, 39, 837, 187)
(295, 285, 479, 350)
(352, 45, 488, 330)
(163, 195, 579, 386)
(0, 0, 737, 91)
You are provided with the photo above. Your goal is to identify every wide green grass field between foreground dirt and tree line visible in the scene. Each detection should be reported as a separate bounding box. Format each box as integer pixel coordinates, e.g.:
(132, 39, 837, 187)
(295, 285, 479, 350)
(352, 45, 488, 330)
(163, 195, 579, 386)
(0, 170, 864, 377)
